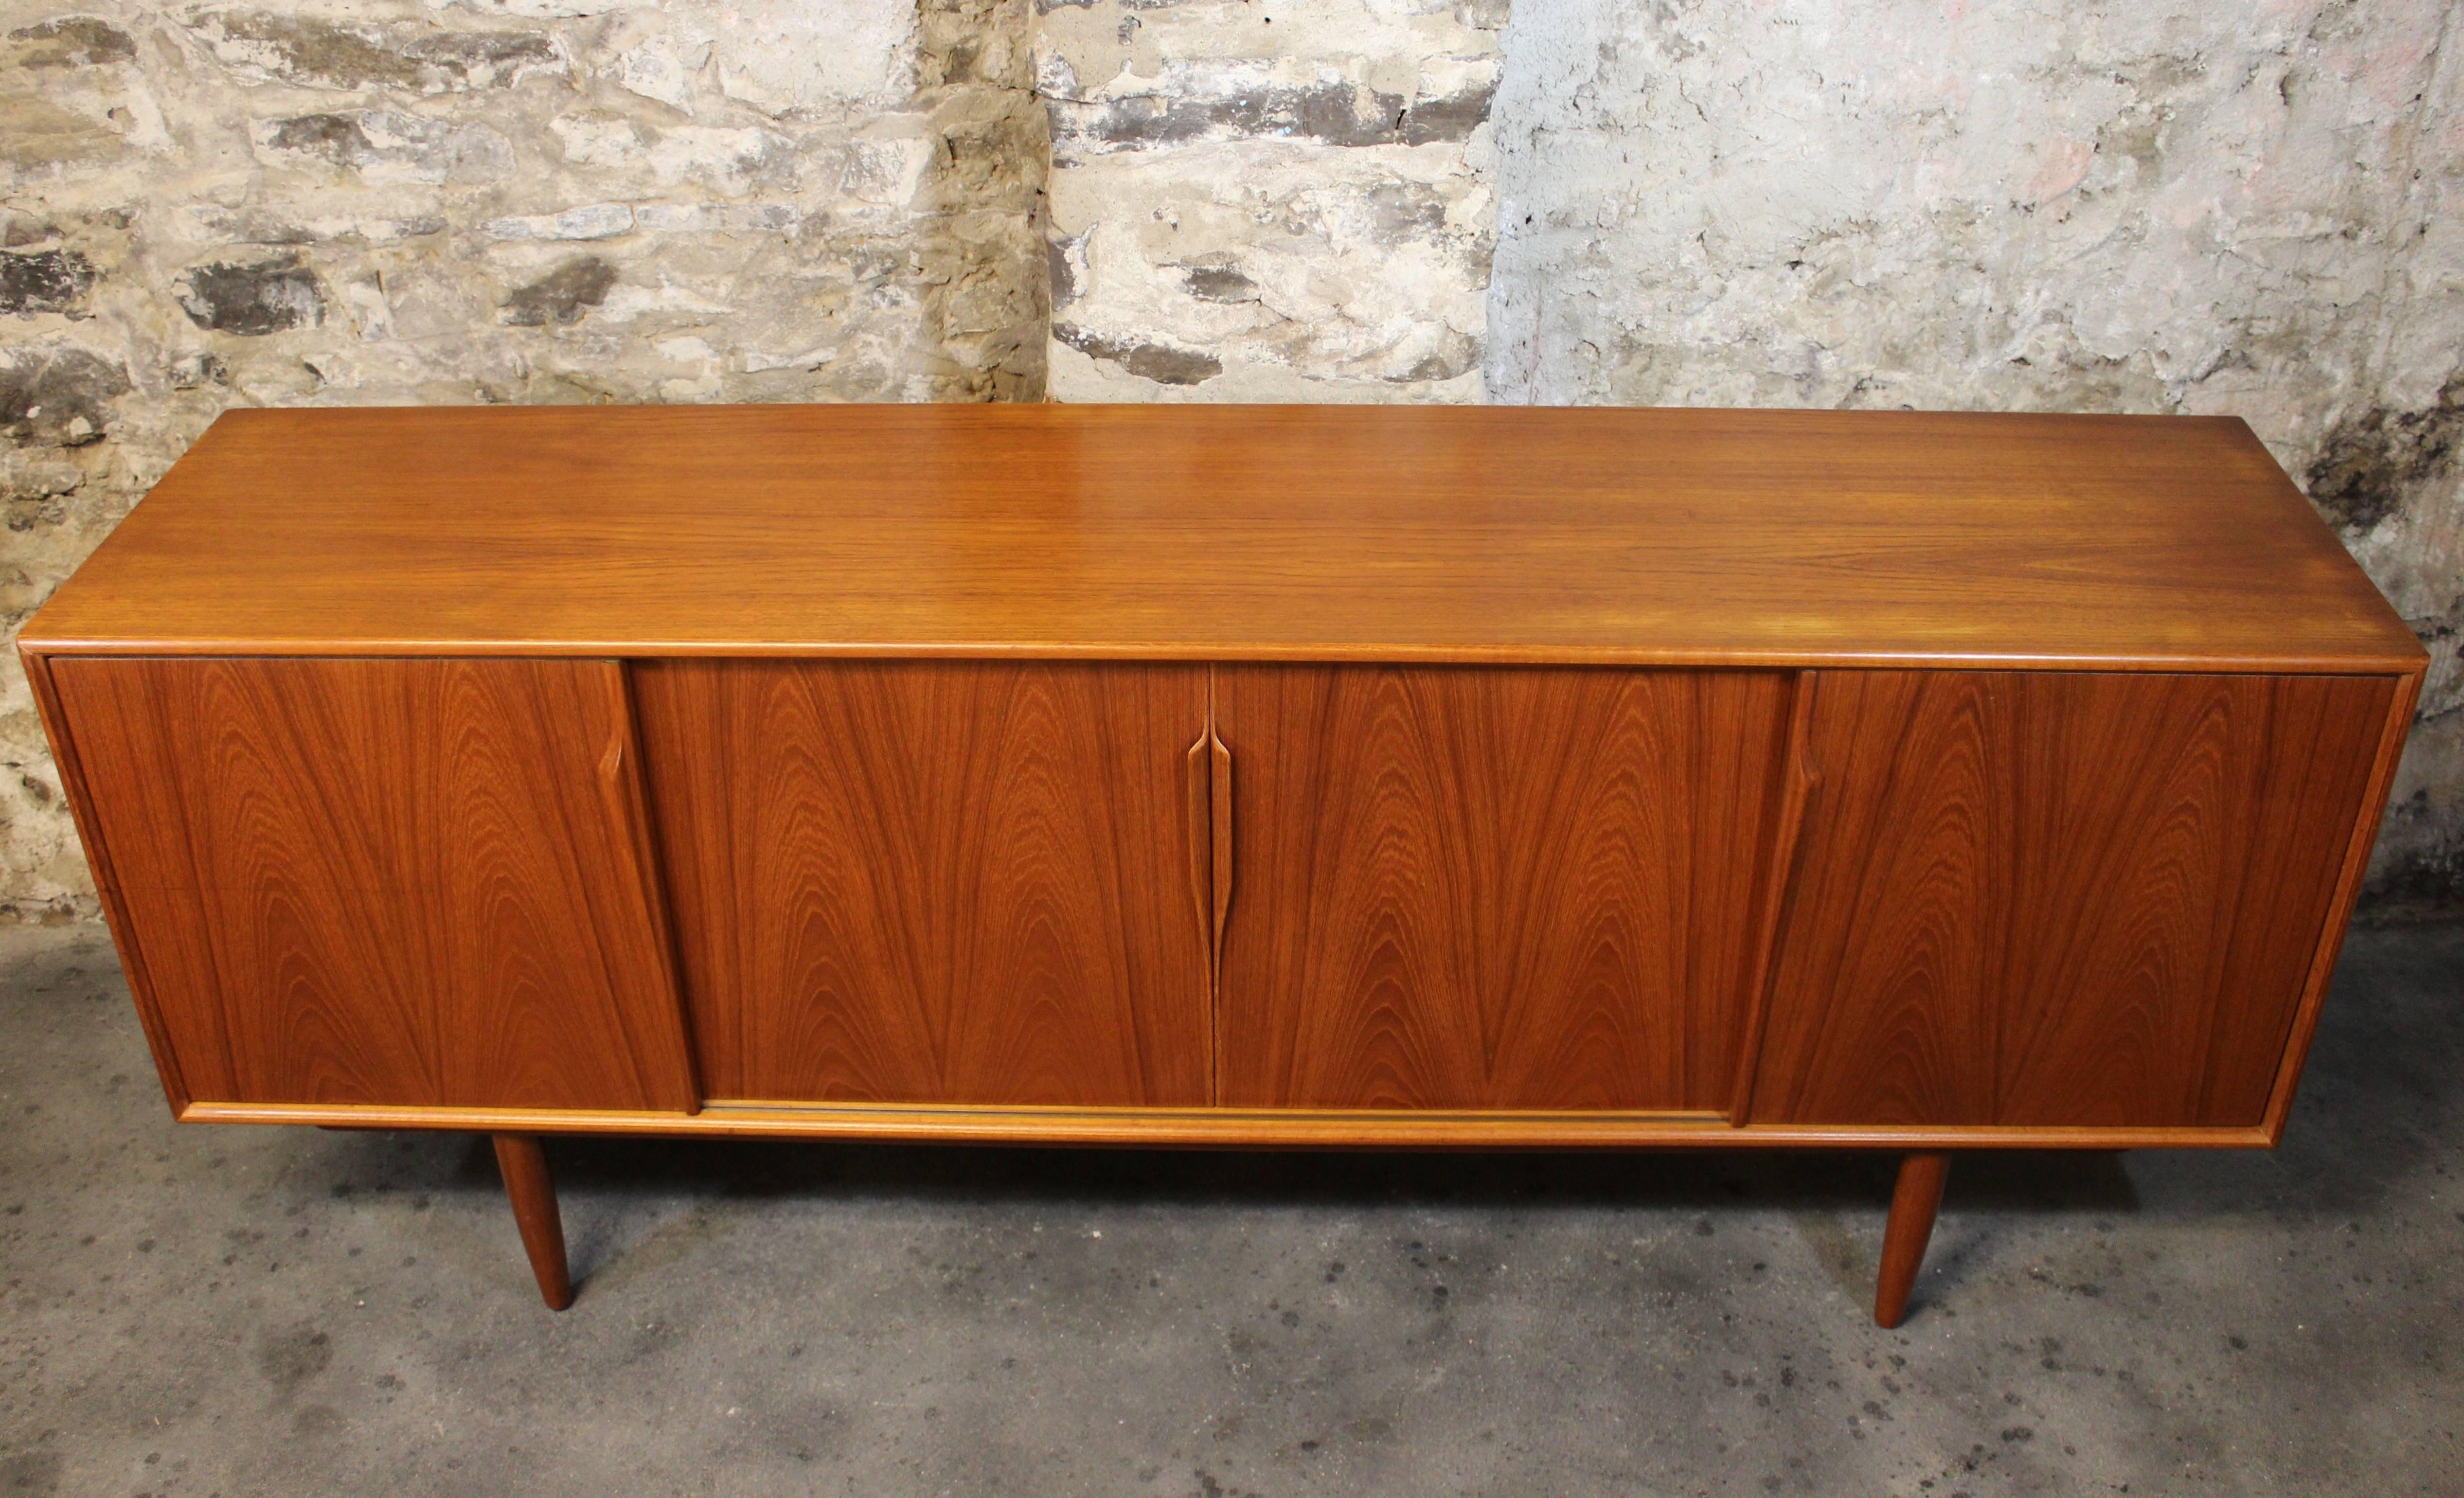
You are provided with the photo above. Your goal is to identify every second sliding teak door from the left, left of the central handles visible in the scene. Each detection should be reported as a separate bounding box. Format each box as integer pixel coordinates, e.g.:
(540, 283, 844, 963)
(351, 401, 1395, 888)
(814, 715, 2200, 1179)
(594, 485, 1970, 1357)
(636, 660, 1212, 1104)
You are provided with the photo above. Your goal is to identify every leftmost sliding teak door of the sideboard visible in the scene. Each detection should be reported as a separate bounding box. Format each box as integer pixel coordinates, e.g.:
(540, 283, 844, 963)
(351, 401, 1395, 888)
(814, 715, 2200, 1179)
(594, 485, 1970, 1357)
(52, 660, 697, 1109)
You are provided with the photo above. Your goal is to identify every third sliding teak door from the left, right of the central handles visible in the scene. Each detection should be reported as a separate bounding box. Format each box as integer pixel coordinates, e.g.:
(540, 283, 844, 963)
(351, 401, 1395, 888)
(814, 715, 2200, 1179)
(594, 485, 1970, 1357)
(1215, 668, 1791, 1109)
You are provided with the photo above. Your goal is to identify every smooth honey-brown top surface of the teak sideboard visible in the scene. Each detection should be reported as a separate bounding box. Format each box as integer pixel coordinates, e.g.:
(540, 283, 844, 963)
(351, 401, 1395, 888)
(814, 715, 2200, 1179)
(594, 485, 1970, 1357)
(22, 404, 2422, 670)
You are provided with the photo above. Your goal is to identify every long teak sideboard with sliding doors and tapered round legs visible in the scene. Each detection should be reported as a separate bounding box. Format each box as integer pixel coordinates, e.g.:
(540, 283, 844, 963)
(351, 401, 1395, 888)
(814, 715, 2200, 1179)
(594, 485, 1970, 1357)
(17, 404, 2425, 1325)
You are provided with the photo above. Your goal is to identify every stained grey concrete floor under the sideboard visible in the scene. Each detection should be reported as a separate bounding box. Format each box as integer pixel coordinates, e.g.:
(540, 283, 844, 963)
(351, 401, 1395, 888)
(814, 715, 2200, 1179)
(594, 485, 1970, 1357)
(0, 927, 2464, 1498)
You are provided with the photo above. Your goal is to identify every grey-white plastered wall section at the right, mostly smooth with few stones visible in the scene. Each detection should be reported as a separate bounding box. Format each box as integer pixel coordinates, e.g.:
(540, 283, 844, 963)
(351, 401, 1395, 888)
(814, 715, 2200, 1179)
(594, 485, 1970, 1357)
(1486, 0, 2464, 902)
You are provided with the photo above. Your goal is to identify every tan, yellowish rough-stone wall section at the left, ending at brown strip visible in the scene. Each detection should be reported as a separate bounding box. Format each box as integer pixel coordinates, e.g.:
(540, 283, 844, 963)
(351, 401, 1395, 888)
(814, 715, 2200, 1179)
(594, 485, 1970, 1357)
(0, 0, 1050, 916)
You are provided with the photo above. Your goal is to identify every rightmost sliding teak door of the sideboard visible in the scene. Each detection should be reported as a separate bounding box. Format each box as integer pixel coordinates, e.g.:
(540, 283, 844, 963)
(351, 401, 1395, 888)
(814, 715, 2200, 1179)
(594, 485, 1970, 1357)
(1752, 673, 2395, 1126)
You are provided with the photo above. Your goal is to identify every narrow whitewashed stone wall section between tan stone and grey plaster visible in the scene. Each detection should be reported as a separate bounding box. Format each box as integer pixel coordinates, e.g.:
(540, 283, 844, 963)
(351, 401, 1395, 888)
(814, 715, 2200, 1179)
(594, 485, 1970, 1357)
(1035, 0, 1505, 402)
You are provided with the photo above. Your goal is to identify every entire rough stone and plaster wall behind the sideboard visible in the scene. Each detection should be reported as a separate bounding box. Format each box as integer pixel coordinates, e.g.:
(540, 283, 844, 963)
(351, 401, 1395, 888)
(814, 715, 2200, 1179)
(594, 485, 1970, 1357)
(0, 0, 2464, 916)
